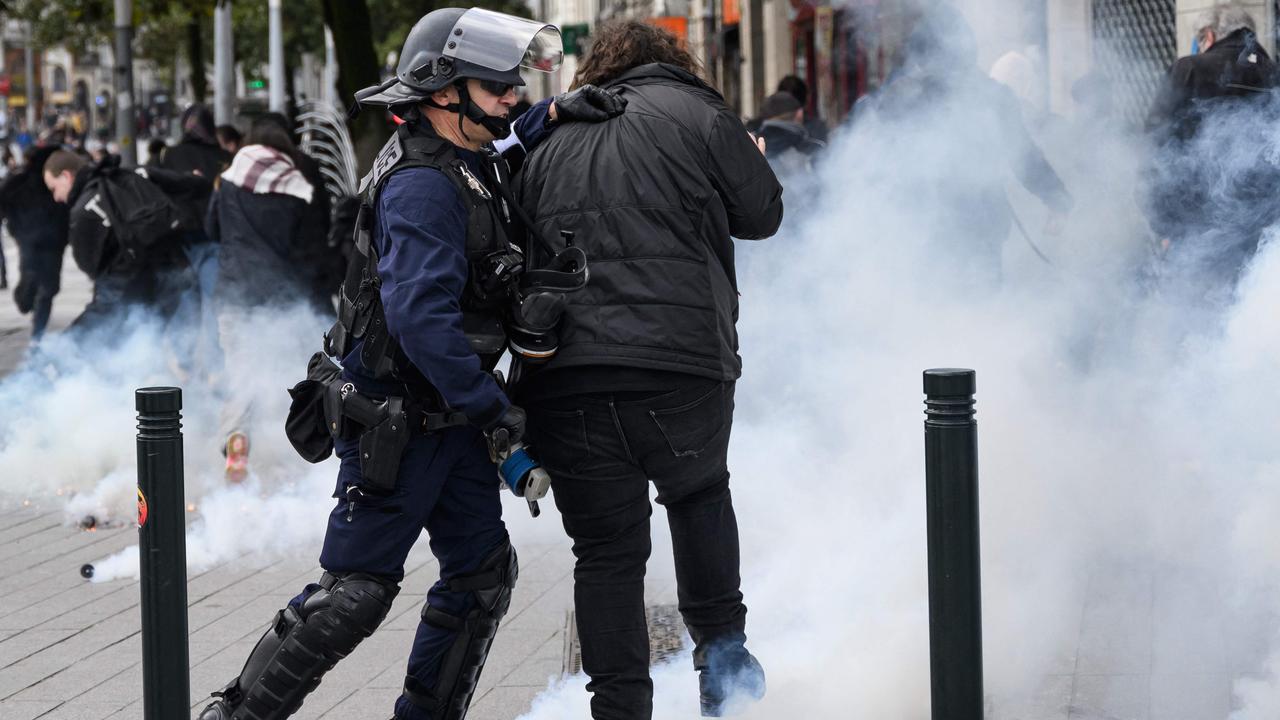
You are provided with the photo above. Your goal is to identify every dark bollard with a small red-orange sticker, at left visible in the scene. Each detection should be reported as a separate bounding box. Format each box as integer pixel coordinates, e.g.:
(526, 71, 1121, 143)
(134, 387, 191, 720)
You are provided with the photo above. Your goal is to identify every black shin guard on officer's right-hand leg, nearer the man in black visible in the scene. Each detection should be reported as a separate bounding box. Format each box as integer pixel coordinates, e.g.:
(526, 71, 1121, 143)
(404, 542, 518, 720)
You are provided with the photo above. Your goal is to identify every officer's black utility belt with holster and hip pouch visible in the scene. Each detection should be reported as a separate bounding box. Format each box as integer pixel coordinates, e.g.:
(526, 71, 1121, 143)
(285, 352, 468, 495)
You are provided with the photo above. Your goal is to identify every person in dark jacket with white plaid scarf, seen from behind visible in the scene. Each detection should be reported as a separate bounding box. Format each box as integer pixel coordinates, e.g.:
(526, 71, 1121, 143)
(205, 118, 324, 480)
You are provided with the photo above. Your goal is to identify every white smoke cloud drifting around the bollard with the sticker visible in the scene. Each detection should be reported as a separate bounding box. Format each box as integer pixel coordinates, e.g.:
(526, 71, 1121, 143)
(0, 299, 337, 582)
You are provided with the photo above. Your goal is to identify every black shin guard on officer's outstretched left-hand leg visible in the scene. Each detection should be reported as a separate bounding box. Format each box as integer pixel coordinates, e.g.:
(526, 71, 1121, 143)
(200, 573, 399, 720)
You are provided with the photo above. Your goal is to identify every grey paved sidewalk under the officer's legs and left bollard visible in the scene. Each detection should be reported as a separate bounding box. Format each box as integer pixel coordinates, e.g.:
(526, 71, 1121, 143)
(0, 499, 572, 720)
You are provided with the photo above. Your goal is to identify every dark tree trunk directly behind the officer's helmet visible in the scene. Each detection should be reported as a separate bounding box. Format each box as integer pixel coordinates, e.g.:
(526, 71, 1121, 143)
(324, 0, 378, 174)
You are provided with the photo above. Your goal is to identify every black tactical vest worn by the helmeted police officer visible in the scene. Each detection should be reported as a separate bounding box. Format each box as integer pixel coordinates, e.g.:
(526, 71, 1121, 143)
(325, 122, 522, 401)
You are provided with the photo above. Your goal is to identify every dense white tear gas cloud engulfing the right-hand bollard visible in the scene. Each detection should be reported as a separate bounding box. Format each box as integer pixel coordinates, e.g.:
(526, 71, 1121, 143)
(524, 1, 1280, 720)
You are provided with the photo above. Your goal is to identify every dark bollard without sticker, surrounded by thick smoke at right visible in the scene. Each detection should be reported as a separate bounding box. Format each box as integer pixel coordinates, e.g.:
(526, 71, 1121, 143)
(924, 369, 983, 720)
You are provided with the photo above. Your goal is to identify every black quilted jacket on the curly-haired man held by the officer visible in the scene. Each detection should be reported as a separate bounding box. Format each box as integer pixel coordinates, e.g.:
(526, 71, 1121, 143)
(518, 64, 782, 380)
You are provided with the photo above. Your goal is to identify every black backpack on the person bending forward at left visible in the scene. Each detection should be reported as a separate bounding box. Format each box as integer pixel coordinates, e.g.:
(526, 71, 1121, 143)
(99, 167, 184, 258)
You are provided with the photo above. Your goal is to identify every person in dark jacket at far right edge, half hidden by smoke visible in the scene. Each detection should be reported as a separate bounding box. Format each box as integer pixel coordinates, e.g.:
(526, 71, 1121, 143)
(1144, 5, 1280, 293)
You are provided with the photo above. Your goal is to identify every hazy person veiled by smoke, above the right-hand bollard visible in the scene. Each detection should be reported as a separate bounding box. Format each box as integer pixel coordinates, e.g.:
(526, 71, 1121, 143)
(858, 4, 1073, 287)
